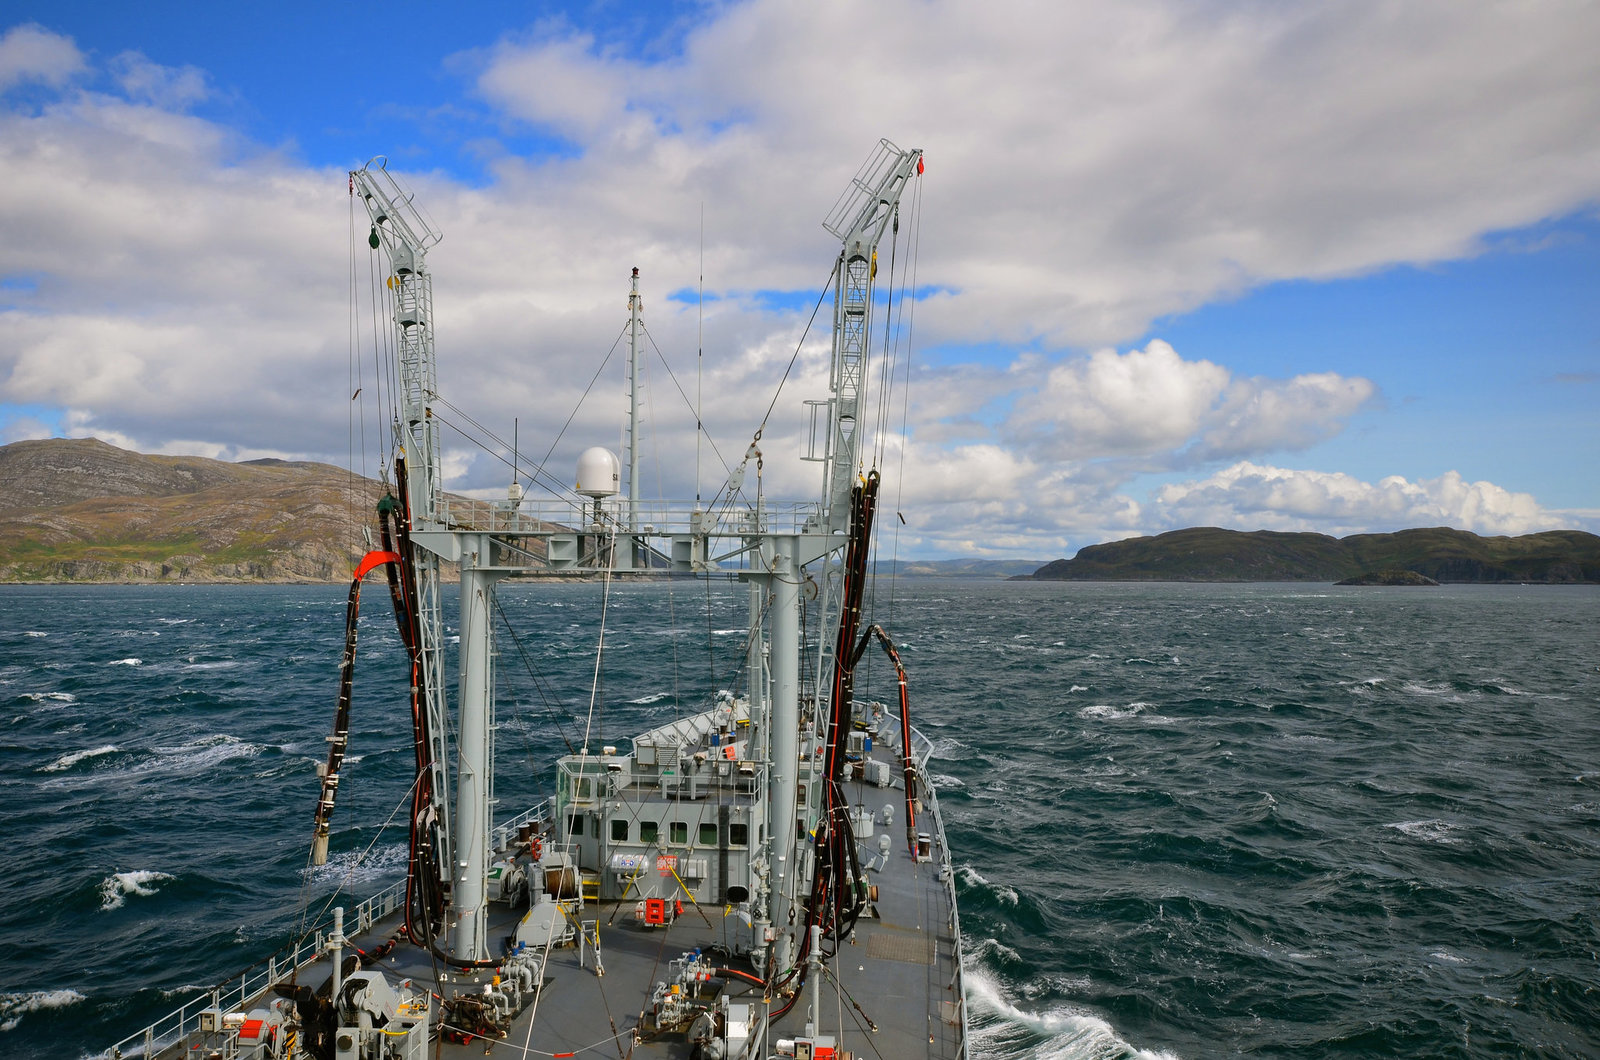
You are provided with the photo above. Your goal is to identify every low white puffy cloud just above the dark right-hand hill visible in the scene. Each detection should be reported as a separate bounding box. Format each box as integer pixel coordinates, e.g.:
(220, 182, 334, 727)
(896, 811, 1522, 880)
(1150, 461, 1571, 535)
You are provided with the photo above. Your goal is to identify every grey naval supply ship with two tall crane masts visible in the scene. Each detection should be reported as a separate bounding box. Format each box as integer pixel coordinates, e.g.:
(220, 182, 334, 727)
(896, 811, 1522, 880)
(106, 139, 968, 1060)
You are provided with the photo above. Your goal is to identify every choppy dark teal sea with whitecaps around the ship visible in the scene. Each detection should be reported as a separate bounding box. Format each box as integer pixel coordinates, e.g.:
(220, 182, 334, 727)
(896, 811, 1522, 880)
(0, 580, 1600, 1060)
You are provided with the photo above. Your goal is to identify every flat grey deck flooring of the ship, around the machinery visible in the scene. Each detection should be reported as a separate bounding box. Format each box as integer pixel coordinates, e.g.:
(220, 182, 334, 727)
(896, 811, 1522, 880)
(124, 745, 966, 1060)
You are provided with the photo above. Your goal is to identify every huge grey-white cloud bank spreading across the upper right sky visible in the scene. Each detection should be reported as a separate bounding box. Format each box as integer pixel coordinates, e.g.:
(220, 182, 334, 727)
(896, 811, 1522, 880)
(464, 0, 1600, 344)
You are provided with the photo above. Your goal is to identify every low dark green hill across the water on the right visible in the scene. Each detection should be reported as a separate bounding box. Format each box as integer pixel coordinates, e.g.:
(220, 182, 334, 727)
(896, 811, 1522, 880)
(1032, 527, 1600, 584)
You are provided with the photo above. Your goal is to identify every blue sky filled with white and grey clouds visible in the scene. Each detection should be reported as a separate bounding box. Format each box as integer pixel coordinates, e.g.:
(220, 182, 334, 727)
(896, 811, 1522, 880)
(0, 0, 1600, 560)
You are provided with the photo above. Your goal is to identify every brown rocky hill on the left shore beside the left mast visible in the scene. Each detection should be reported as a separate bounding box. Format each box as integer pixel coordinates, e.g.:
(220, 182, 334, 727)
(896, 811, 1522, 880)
(0, 439, 379, 581)
